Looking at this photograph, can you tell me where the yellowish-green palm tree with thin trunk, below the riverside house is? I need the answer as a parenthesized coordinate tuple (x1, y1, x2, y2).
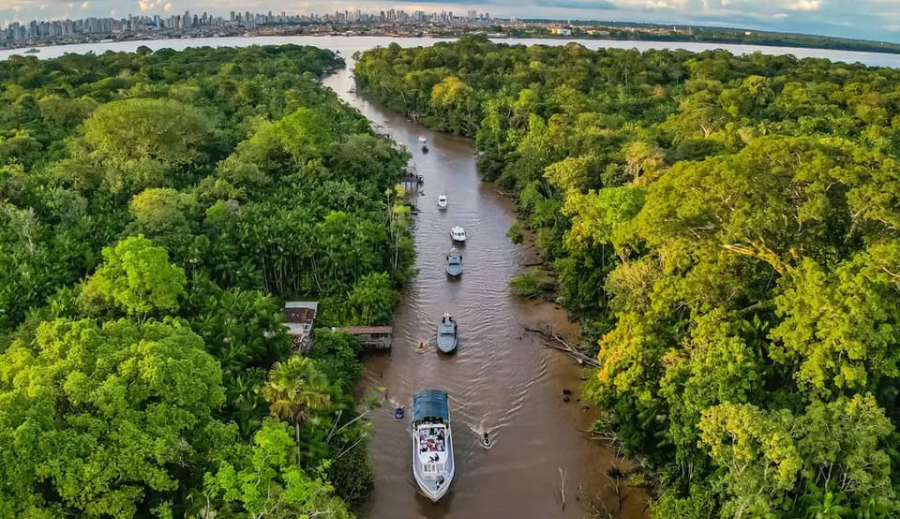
(263, 356, 331, 466)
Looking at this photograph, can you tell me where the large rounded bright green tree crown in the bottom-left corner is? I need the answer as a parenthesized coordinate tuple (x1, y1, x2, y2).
(0, 320, 231, 518)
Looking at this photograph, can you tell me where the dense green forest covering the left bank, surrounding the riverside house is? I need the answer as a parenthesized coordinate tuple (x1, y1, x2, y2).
(0, 46, 413, 519)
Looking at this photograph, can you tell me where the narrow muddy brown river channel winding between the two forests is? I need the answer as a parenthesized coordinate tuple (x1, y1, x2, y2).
(324, 56, 647, 519)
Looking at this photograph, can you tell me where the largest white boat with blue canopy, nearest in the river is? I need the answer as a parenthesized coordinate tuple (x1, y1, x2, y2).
(412, 389, 456, 502)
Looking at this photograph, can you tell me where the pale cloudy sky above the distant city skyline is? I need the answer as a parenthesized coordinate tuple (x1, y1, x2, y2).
(0, 0, 900, 42)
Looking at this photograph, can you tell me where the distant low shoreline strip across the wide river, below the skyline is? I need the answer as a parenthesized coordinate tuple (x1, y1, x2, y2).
(0, 20, 900, 58)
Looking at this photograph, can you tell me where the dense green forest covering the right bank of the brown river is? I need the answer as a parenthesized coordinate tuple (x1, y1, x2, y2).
(355, 37, 900, 519)
